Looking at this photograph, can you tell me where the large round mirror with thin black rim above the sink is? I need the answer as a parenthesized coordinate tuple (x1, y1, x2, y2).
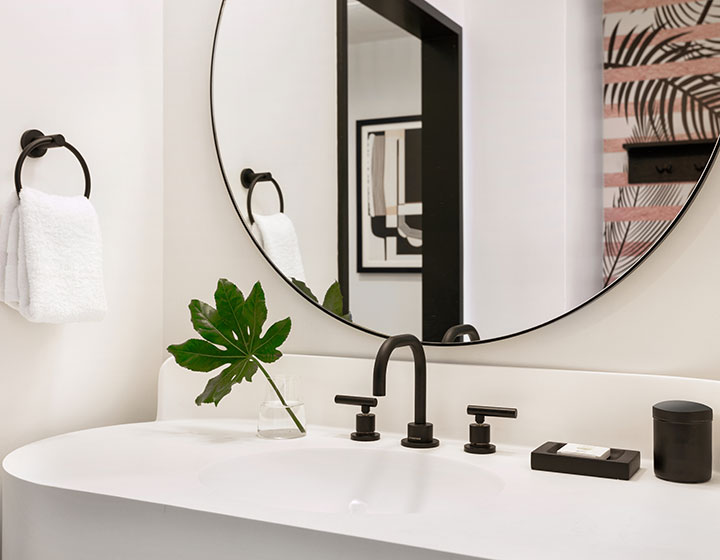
(211, 0, 720, 344)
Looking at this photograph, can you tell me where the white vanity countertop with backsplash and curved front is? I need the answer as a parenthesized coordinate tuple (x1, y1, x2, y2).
(3, 355, 720, 560)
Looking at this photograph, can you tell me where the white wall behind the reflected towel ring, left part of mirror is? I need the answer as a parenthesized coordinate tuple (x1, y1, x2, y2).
(212, 0, 338, 299)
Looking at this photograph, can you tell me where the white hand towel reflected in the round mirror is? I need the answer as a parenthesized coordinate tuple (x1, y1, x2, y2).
(253, 212, 305, 282)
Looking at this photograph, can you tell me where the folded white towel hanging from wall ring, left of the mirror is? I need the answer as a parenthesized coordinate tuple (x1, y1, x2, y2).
(4, 188, 107, 323)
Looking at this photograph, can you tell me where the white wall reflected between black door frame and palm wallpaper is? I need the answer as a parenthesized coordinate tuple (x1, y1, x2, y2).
(464, 0, 602, 338)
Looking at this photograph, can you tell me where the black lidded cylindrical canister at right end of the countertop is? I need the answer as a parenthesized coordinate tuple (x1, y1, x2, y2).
(653, 401, 712, 482)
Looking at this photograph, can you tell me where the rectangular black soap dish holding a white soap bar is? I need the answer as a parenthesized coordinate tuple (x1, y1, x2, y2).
(530, 441, 640, 480)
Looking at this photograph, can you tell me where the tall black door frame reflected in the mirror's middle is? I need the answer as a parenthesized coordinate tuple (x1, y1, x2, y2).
(337, 0, 464, 343)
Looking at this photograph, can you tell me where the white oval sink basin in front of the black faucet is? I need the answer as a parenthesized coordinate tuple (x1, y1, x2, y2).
(199, 448, 503, 515)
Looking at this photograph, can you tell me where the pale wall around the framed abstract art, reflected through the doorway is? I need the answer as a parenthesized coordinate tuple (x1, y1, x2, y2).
(348, 35, 422, 336)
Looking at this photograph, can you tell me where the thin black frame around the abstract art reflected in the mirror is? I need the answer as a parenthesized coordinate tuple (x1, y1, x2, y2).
(355, 115, 422, 274)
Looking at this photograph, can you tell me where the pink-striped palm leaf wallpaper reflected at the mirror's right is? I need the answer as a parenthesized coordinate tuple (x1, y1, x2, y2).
(603, 0, 720, 286)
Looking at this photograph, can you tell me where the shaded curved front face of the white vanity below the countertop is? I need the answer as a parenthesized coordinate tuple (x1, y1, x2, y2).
(2, 468, 478, 560)
